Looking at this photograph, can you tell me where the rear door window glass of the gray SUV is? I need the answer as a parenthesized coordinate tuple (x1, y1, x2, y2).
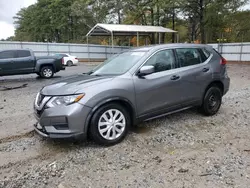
(176, 48, 202, 67)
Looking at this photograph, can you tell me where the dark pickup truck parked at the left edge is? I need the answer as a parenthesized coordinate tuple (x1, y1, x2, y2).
(0, 49, 65, 78)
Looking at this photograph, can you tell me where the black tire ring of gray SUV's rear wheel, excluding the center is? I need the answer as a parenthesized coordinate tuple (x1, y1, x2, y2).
(202, 86, 222, 116)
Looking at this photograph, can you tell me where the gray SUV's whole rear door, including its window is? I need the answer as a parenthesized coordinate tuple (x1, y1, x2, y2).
(176, 48, 212, 106)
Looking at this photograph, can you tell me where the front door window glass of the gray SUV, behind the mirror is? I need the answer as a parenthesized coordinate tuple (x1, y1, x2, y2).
(144, 50, 175, 72)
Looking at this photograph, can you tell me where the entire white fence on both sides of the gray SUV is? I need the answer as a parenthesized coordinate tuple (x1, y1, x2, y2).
(0, 41, 250, 61)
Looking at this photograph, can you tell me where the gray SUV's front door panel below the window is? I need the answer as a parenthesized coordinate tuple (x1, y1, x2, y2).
(134, 69, 182, 116)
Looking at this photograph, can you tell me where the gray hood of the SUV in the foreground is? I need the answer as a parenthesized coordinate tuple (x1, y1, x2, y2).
(41, 75, 113, 96)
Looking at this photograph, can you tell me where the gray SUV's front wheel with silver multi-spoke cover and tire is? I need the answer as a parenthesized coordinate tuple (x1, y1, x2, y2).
(90, 103, 130, 146)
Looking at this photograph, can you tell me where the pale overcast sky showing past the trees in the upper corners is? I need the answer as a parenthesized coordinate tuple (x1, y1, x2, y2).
(0, 0, 250, 39)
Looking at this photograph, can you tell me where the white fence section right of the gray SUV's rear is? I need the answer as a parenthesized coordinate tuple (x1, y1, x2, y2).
(210, 43, 250, 61)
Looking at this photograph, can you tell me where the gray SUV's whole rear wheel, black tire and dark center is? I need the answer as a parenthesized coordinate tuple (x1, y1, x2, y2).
(201, 86, 222, 116)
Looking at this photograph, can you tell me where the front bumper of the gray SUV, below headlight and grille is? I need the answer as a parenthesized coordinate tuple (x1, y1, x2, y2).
(34, 103, 91, 139)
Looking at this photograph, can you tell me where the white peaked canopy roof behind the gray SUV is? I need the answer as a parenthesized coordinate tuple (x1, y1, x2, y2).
(87, 24, 176, 36)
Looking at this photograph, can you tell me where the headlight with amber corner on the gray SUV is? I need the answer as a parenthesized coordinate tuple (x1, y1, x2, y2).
(46, 94, 85, 108)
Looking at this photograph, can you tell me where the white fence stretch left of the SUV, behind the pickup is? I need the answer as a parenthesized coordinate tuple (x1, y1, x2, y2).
(0, 41, 129, 59)
